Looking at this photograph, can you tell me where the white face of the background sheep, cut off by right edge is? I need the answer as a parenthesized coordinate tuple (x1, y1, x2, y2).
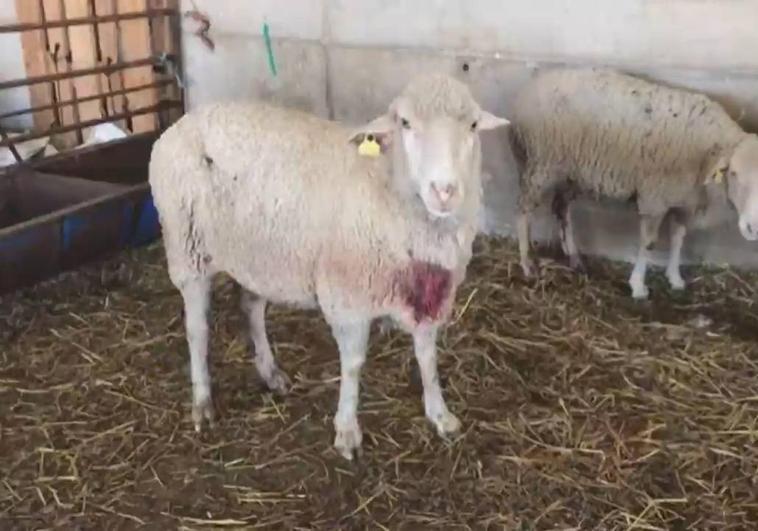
(726, 135, 758, 241)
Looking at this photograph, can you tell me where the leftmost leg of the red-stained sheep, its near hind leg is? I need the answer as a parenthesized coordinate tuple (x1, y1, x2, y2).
(179, 278, 218, 432)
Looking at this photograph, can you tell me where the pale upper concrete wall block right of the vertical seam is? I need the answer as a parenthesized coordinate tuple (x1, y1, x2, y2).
(325, 0, 758, 70)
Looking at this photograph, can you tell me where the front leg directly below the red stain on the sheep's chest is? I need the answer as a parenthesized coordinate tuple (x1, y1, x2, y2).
(413, 325, 461, 436)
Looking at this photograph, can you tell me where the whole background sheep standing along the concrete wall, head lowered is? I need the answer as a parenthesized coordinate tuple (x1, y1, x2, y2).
(509, 69, 758, 298)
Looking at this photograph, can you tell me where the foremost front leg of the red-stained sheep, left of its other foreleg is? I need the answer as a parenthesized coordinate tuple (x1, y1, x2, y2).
(332, 321, 371, 460)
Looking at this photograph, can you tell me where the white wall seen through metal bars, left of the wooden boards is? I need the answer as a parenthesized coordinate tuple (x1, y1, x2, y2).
(0, 0, 32, 129)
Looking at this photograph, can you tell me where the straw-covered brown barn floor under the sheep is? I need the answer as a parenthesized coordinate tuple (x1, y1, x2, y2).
(0, 240, 758, 530)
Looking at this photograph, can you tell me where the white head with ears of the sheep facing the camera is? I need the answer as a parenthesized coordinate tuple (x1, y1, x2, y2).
(351, 75, 509, 218)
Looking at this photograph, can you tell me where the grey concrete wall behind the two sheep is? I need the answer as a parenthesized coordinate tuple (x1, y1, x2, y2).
(183, 0, 758, 265)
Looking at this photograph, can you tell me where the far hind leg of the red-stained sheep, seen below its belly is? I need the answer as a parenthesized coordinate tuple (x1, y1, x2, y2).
(240, 288, 290, 395)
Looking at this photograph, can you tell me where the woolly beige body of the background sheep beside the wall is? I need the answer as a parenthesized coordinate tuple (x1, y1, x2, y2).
(513, 69, 739, 202)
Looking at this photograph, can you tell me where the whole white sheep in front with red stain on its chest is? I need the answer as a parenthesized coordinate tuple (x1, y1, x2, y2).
(150, 72, 508, 459)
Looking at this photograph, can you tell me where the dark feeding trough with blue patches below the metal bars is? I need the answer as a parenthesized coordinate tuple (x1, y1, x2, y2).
(0, 134, 159, 293)
